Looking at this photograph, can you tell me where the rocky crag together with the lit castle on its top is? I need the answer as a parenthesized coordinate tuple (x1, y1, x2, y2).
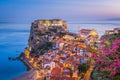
(28, 19, 69, 53)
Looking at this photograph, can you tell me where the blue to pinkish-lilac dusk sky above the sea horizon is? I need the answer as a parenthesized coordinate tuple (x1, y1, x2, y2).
(0, 0, 120, 21)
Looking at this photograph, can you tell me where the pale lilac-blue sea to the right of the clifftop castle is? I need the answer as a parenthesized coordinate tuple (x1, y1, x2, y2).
(68, 21, 120, 36)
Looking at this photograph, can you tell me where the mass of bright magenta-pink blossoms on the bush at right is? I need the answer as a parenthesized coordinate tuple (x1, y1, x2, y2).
(93, 38, 120, 78)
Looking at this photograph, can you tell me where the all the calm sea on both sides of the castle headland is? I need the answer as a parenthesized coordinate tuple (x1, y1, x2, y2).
(0, 21, 120, 80)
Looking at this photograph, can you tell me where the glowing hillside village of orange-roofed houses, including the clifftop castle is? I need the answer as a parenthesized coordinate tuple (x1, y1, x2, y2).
(13, 19, 120, 80)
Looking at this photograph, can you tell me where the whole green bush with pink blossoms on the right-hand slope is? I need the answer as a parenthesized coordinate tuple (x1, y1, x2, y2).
(92, 35, 120, 80)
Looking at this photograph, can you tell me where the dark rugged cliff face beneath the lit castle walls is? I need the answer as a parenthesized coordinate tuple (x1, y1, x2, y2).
(28, 20, 68, 54)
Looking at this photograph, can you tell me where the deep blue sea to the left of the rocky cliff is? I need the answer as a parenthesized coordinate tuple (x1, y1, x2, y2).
(0, 24, 30, 80)
